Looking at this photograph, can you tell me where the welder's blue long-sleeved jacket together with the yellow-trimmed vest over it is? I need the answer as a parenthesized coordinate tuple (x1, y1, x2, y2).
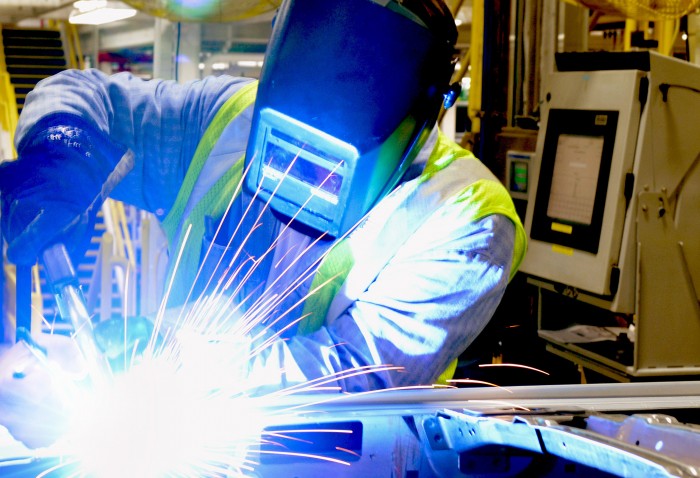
(16, 70, 525, 391)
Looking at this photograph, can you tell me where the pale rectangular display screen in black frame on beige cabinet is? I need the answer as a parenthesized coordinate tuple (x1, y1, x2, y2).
(547, 134, 605, 226)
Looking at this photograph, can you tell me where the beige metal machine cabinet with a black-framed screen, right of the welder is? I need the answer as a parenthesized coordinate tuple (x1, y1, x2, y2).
(521, 52, 700, 381)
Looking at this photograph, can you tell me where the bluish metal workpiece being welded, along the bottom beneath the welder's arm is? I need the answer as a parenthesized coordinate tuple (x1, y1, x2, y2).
(0, 382, 700, 478)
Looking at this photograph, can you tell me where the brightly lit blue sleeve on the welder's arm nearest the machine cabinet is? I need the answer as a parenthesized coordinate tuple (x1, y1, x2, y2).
(251, 213, 514, 392)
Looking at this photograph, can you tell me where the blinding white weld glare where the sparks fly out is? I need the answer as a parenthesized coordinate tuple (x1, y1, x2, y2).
(67, 359, 264, 478)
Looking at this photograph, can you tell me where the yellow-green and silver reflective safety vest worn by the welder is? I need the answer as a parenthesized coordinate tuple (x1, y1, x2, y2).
(163, 82, 526, 380)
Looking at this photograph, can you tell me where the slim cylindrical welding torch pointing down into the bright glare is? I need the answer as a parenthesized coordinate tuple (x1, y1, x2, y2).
(42, 244, 110, 384)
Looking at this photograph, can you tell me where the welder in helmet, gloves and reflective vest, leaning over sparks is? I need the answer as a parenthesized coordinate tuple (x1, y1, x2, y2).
(0, 0, 525, 448)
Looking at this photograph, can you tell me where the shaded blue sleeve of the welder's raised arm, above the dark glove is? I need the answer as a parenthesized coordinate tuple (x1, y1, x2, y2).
(15, 70, 250, 217)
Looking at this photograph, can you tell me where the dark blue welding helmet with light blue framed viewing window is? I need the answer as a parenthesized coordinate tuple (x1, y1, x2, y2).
(245, 0, 457, 237)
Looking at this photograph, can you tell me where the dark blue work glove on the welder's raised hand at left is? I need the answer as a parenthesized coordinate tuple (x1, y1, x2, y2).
(0, 115, 133, 265)
